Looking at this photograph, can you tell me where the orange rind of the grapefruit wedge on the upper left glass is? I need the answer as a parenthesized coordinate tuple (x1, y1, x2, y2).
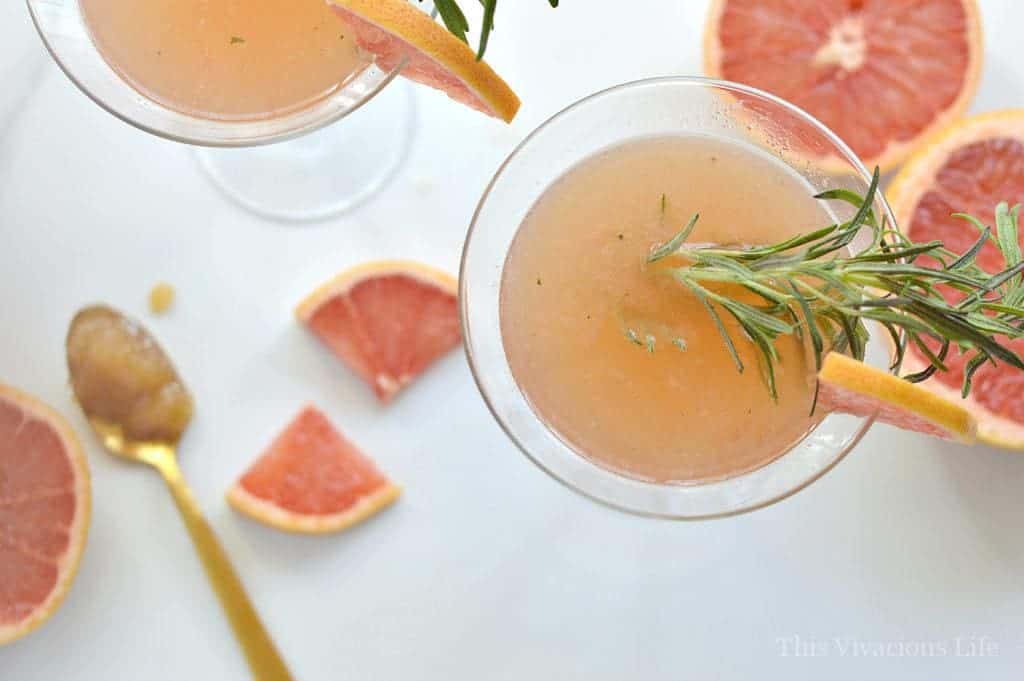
(328, 0, 520, 123)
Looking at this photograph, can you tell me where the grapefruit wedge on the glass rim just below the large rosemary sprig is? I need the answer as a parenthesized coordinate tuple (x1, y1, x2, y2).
(817, 352, 977, 442)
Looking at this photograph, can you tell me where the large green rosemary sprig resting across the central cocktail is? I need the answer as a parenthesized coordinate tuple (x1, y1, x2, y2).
(648, 170, 1024, 398)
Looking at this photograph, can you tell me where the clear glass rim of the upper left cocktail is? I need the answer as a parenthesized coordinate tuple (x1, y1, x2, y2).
(26, 0, 437, 148)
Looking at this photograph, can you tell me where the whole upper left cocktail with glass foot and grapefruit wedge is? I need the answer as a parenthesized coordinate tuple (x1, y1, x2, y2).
(27, 0, 519, 220)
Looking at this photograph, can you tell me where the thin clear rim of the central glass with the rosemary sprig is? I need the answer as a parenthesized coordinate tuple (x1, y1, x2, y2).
(459, 76, 895, 521)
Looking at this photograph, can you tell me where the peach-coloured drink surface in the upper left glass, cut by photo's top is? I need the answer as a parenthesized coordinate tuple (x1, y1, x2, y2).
(81, 0, 365, 120)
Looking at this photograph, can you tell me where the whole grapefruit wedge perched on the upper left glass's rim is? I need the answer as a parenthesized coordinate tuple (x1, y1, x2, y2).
(328, 0, 519, 122)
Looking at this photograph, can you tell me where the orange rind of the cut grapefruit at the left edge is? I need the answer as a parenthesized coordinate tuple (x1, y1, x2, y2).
(0, 383, 92, 645)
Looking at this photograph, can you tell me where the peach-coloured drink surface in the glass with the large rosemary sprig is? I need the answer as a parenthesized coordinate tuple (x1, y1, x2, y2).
(501, 136, 829, 482)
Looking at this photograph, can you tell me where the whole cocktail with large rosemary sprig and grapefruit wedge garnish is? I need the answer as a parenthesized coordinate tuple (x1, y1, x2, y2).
(461, 78, 1024, 518)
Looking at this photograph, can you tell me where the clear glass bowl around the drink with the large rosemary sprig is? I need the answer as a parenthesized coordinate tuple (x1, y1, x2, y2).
(460, 78, 892, 519)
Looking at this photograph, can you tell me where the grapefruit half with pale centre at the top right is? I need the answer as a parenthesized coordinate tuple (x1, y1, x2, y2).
(705, 0, 983, 170)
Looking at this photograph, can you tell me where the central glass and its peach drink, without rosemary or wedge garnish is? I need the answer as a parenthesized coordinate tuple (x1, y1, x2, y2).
(461, 78, 901, 518)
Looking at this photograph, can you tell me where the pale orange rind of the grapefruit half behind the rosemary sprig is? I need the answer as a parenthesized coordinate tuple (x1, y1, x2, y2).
(886, 109, 1024, 451)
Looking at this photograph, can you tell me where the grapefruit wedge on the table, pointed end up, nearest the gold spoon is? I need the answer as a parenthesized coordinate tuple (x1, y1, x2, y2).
(227, 407, 400, 535)
